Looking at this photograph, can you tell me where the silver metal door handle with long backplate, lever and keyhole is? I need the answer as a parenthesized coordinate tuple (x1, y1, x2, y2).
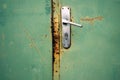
(61, 6, 83, 49)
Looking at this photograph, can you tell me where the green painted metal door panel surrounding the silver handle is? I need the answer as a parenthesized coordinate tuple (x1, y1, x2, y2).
(60, 0, 120, 80)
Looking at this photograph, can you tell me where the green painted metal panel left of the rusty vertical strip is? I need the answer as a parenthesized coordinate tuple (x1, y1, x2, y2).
(0, 0, 52, 80)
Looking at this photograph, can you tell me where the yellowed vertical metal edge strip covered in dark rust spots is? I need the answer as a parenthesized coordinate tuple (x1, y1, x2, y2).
(51, 0, 60, 80)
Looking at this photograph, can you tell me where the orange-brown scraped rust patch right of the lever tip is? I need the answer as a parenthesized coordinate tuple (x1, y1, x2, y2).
(80, 16, 103, 24)
